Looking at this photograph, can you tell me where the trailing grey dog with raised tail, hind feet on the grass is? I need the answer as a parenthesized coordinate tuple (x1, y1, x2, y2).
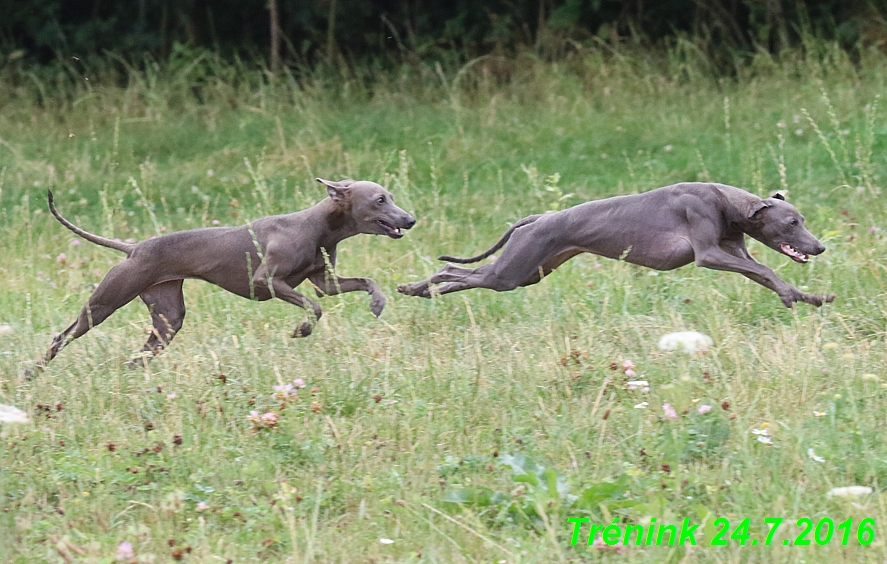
(37, 178, 416, 368)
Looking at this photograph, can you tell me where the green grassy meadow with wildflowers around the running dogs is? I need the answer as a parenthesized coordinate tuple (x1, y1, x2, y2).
(0, 47, 887, 563)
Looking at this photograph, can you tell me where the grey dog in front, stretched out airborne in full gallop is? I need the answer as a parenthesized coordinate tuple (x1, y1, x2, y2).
(397, 182, 835, 307)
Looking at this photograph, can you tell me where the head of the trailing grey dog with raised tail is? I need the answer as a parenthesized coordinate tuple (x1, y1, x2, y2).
(317, 178, 416, 239)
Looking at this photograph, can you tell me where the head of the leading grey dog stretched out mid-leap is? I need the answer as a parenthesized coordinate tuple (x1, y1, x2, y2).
(748, 194, 825, 263)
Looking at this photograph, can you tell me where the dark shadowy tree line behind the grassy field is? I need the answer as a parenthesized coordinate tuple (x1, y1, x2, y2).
(0, 0, 887, 68)
